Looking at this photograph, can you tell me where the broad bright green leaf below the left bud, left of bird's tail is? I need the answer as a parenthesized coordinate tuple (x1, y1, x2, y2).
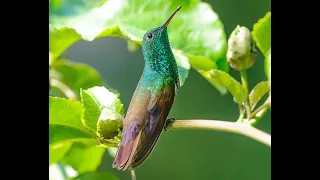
(61, 143, 105, 174)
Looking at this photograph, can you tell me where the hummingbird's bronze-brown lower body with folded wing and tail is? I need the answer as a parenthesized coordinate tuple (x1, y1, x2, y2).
(113, 82, 176, 170)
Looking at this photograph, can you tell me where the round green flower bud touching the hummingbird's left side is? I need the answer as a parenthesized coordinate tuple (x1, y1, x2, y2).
(97, 108, 124, 147)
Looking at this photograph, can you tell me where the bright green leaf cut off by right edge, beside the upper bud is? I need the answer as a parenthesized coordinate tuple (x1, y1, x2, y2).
(252, 12, 271, 56)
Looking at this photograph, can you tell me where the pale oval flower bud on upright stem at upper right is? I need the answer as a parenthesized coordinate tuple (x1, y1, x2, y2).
(227, 25, 257, 71)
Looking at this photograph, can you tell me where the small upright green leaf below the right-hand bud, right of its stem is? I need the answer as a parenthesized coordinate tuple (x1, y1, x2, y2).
(249, 81, 270, 110)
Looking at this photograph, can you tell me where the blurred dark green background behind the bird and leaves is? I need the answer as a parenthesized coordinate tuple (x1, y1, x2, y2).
(64, 0, 271, 180)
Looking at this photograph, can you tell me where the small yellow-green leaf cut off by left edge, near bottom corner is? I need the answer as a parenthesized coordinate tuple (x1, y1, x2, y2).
(49, 143, 72, 165)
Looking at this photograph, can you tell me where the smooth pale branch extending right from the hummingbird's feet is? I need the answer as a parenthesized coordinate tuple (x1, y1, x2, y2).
(166, 119, 271, 147)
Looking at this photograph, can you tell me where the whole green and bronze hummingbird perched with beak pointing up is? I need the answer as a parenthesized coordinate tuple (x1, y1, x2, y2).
(112, 6, 181, 171)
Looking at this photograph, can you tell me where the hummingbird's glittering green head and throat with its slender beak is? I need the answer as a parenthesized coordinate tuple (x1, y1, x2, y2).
(142, 6, 181, 74)
